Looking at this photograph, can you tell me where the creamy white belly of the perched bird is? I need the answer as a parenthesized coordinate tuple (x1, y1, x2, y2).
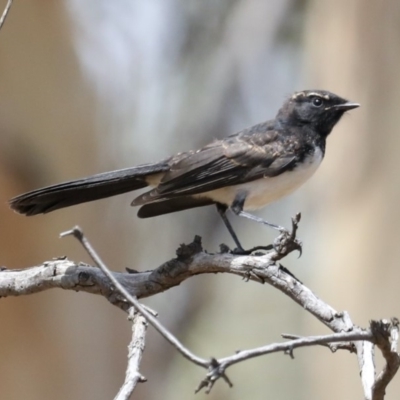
(201, 148, 323, 210)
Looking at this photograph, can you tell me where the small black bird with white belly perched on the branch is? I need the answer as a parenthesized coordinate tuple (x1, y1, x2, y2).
(9, 90, 360, 251)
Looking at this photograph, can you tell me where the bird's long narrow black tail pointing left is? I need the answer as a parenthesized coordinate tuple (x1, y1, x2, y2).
(9, 160, 169, 215)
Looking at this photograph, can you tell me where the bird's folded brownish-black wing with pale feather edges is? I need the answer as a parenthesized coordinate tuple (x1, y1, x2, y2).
(132, 130, 296, 205)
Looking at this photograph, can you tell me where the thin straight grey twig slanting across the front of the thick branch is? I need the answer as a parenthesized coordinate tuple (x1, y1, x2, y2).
(60, 227, 210, 368)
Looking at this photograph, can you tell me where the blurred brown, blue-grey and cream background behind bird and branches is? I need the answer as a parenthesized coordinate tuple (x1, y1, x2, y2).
(0, 0, 400, 400)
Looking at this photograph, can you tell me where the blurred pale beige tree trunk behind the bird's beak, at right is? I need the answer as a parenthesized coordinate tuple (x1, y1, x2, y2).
(304, 0, 400, 399)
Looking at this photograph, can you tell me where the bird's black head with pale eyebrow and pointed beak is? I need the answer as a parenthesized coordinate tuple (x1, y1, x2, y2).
(277, 90, 360, 136)
